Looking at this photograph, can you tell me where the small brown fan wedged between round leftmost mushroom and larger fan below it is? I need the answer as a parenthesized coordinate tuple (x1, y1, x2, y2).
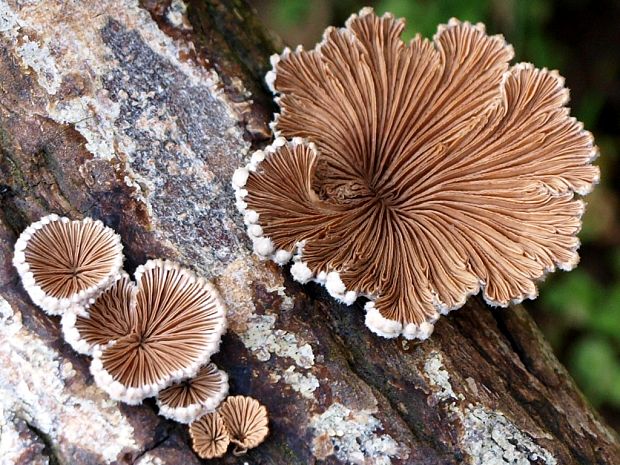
(61, 272, 137, 355)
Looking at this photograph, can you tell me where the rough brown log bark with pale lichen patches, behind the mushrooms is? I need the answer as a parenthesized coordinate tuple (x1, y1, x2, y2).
(0, 0, 620, 465)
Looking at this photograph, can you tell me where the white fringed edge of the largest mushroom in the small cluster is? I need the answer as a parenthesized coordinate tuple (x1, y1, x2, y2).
(90, 259, 226, 405)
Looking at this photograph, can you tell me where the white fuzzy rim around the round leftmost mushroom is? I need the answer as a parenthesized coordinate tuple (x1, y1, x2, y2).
(13, 213, 124, 315)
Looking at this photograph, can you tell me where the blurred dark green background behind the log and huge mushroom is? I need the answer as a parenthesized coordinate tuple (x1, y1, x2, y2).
(251, 0, 620, 430)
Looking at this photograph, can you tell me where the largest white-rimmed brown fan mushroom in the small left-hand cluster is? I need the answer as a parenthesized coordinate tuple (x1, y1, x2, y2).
(91, 260, 226, 404)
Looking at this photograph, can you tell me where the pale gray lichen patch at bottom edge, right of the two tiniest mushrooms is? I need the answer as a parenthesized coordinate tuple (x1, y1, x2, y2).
(310, 403, 400, 465)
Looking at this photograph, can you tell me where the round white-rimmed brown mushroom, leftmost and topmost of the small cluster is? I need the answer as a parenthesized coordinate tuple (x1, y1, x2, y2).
(13, 214, 123, 315)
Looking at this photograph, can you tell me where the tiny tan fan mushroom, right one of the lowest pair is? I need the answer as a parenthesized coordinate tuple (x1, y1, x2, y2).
(218, 396, 269, 454)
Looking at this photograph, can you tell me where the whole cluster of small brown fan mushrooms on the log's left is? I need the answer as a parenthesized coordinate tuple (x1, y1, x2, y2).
(13, 214, 269, 458)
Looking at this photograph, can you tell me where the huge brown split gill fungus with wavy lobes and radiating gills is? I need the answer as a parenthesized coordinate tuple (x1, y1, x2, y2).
(232, 8, 599, 339)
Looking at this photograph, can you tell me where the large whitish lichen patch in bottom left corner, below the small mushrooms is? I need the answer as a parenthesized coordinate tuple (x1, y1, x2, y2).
(0, 297, 137, 463)
